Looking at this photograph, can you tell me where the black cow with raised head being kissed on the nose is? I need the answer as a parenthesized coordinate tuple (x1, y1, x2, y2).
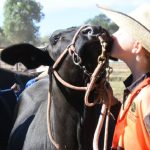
(1, 26, 120, 150)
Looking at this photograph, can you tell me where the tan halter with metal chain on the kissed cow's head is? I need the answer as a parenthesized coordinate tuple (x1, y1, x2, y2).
(47, 25, 111, 149)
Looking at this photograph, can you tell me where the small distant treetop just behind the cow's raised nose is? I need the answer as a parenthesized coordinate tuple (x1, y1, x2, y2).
(85, 14, 118, 33)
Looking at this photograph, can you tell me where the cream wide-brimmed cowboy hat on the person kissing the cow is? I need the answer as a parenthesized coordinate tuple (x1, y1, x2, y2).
(98, 4, 150, 52)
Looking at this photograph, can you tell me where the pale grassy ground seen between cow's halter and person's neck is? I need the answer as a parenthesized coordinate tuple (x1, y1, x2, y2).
(110, 62, 130, 101)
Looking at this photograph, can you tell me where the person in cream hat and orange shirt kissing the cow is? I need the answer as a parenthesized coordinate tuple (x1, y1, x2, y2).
(99, 4, 150, 150)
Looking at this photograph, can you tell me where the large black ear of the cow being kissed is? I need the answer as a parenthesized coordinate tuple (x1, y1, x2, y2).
(1, 43, 54, 69)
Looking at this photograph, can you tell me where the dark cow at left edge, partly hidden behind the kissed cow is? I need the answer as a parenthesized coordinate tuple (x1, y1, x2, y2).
(0, 68, 38, 150)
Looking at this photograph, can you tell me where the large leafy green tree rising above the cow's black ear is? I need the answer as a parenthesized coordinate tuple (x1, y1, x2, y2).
(3, 0, 44, 43)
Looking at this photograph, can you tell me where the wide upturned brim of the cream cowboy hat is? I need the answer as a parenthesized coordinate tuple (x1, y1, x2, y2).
(97, 5, 150, 52)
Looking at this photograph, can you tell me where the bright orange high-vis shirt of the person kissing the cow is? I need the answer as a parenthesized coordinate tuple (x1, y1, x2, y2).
(112, 77, 150, 150)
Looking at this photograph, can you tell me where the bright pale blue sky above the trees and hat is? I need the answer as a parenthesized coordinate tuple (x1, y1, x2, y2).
(0, 0, 150, 36)
